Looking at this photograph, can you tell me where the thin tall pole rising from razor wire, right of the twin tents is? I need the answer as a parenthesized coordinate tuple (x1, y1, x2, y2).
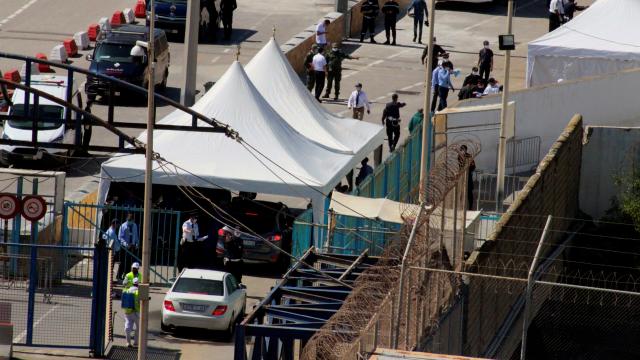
(414, 0, 437, 202)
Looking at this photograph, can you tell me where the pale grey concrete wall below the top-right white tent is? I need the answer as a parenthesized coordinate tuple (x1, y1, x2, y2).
(448, 69, 640, 171)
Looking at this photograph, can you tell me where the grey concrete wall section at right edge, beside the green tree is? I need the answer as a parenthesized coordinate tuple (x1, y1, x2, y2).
(580, 126, 640, 219)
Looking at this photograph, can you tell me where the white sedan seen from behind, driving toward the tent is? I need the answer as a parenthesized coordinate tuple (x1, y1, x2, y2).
(161, 269, 247, 338)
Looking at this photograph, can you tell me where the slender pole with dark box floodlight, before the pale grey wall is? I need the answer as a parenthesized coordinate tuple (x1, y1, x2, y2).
(496, 0, 514, 212)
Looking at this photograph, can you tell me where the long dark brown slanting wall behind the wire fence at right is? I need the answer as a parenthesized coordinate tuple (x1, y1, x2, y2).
(465, 116, 583, 355)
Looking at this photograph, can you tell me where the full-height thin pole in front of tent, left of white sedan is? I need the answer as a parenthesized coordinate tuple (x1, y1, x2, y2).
(137, 0, 156, 360)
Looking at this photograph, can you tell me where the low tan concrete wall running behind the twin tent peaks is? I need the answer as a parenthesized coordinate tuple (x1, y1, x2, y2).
(281, 0, 411, 74)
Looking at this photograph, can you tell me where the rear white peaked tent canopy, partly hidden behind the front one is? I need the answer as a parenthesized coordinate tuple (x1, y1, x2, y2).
(246, 39, 384, 158)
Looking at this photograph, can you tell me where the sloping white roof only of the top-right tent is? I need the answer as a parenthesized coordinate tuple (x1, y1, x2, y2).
(528, 0, 640, 61)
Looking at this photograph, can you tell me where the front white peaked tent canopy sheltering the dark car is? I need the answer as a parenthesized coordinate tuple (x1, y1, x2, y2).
(100, 62, 353, 226)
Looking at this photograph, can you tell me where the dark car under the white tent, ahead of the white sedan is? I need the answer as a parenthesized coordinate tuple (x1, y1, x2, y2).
(216, 197, 295, 267)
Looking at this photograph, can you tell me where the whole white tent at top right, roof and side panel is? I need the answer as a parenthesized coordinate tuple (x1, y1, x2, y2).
(527, 0, 640, 87)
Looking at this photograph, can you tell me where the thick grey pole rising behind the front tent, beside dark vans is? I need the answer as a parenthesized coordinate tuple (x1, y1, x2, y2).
(180, 0, 200, 107)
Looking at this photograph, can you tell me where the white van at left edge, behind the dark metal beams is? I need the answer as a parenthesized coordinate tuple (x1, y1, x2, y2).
(0, 75, 82, 165)
